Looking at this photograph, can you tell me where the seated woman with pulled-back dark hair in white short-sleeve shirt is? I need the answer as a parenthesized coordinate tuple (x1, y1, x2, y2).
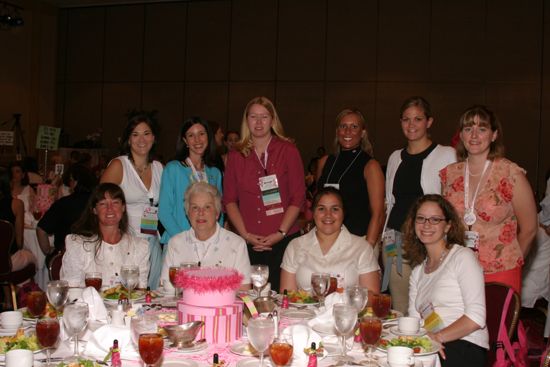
(280, 187, 380, 293)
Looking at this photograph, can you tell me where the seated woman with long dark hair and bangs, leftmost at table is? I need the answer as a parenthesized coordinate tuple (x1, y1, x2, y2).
(60, 183, 149, 288)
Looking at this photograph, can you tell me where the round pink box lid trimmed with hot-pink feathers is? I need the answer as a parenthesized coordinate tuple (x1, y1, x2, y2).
(176, 267, 244, 293)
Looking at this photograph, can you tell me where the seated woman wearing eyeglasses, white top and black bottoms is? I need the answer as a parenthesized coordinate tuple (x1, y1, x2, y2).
(403, 194, 489, 367)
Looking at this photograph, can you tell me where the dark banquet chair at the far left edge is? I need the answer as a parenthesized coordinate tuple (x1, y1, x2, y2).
(0, 219, 36, 310)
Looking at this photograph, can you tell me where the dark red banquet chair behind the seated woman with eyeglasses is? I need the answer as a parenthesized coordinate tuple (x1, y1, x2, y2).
(485, 282, 521, 366)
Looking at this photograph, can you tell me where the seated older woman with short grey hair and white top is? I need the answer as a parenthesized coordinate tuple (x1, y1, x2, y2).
(161, 182, 250, 292)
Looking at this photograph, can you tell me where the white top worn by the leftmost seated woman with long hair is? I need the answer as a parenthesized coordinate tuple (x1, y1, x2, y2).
(60, 234, 149, 288)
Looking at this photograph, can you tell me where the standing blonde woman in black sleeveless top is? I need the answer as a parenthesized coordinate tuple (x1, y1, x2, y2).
(317, 108, 384, 248)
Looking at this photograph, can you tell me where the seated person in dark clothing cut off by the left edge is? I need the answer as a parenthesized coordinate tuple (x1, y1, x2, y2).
(0, 180, 36, 271)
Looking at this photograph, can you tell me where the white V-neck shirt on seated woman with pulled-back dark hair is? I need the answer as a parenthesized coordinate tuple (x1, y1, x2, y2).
(281, 226, 380, 289)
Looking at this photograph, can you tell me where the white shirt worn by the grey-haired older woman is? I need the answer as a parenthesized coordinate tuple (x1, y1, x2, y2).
(161, 223, 250, 289)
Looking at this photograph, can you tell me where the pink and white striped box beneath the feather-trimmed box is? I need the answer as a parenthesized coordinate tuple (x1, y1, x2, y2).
(178, 301, 243, 344)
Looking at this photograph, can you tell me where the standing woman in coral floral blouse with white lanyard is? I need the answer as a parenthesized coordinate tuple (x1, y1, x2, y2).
(440, 106, 537, 294)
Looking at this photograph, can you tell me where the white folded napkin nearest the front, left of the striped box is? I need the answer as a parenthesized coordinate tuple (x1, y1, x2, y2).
(84, 325, 139, 359)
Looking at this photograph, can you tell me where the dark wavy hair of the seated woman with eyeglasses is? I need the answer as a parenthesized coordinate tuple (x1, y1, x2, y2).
(402, 194, 464, 267)
